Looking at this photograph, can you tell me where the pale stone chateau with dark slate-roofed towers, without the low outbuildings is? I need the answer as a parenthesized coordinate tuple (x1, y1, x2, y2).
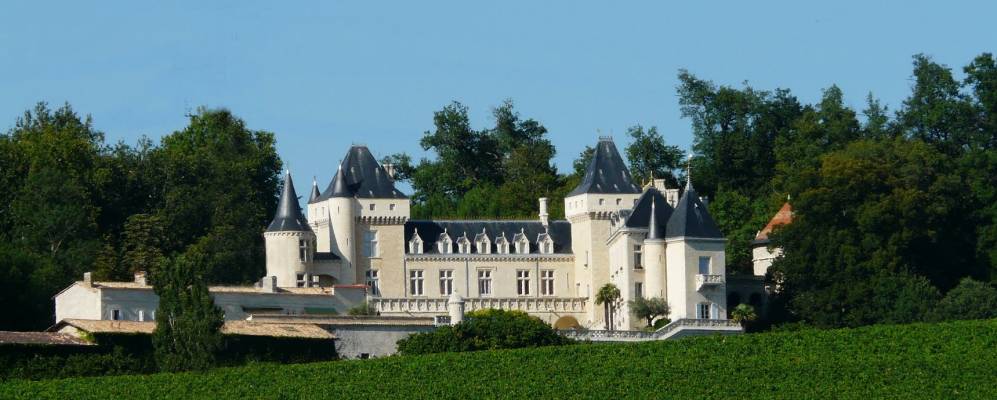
(264, 138, 727, 330)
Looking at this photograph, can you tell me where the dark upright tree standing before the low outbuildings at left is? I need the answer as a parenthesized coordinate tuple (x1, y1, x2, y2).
(152, 251, 224, 371)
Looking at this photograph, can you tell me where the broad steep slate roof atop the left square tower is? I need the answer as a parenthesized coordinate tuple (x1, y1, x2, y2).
(316, 145, 406, 201)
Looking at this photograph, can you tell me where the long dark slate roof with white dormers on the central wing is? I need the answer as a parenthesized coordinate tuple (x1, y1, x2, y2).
(405, 220, 571, 254)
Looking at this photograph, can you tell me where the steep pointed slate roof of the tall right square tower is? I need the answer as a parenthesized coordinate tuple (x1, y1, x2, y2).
(568, 138, 640, 196)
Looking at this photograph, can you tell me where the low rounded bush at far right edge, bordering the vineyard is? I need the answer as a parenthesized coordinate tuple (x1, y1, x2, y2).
(929, 278, 997, 321)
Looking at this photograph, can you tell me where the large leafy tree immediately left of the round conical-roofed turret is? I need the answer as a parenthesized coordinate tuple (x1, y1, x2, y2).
(151, 108, 281, 283)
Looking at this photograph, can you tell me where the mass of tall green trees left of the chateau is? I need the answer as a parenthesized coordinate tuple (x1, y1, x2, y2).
(0, 104, 281, 330)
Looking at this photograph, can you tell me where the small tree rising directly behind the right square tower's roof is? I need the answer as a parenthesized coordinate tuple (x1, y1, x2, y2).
(626, 125, 684, 187)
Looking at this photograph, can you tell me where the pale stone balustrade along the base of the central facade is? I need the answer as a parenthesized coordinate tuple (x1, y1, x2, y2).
(370, 297, 587, 314)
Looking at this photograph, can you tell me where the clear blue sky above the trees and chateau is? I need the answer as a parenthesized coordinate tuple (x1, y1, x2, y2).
(0, 1, 997, 190)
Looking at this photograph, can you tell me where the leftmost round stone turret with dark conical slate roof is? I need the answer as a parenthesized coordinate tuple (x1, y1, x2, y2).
(263, 172, 315, 287)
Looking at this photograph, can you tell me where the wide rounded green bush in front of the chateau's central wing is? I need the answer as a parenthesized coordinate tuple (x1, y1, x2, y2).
(398, 309, 573, 355)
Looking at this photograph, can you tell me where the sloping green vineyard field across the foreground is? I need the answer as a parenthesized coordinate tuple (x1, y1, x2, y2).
(0, 320, 997, 399)
